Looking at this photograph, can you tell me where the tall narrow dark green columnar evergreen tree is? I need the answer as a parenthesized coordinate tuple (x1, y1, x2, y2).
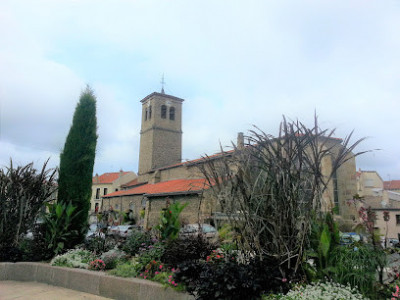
(58, 86, 97, 247)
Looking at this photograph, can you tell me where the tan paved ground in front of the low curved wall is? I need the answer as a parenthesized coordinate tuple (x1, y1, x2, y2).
(0, 281, 110, 300)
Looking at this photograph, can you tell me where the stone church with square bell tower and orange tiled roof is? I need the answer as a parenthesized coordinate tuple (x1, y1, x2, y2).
(101, 90, 356, 229)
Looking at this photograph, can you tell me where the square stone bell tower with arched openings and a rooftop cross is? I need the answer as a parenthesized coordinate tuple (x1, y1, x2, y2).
(138, 89, 184, 175)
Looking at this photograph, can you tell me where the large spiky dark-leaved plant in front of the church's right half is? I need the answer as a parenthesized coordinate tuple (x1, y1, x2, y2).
(200, 117, 364, 278)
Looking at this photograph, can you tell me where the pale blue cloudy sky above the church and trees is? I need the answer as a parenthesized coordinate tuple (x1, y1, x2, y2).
(0, 0, 400, 180)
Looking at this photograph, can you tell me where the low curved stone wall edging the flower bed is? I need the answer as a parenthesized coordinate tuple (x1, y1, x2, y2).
(0, 262, 193, 300)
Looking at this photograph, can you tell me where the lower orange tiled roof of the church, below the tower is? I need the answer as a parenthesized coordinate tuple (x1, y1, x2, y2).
(103, 179, 209, 198)
